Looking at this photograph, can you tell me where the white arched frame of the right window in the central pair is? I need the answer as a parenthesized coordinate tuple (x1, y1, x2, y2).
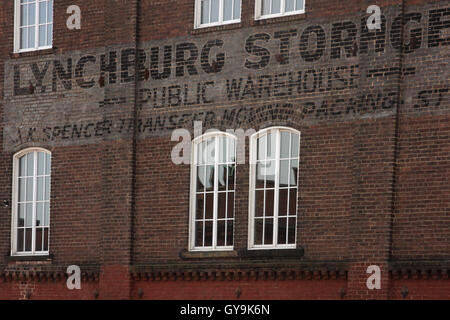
(248, 127, 301, 250)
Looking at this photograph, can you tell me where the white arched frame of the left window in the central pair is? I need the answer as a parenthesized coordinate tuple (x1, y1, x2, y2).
(189, 131, 237, 251)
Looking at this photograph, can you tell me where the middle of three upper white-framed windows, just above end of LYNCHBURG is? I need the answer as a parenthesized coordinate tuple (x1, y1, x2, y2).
(195, 0, 242, 28)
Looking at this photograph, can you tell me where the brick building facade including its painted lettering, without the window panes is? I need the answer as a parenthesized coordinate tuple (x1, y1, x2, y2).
(0, 0, 450, 299)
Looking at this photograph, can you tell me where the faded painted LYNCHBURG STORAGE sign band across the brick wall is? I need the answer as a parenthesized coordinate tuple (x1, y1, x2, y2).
(4, 7, 450, 147)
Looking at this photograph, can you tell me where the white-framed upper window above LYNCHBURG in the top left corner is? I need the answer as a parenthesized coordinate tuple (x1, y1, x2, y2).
(14, 0, 53, 52)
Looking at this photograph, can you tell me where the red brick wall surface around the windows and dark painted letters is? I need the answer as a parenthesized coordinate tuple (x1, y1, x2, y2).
(0, 0, 450, 299)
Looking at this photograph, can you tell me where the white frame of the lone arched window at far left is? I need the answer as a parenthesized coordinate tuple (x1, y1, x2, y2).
(11, 147, 52, 256)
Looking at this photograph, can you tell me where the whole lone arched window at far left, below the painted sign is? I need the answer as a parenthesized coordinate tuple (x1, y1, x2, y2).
(11, 148, 51, 255)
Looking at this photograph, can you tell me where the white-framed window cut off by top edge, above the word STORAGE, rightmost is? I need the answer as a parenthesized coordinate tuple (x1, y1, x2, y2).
(255, 0, 305, 19)
